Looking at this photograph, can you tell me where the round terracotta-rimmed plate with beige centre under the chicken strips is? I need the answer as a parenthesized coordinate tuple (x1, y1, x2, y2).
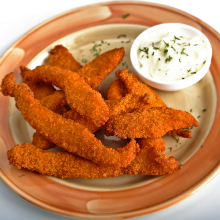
(0, 1, 220, 219)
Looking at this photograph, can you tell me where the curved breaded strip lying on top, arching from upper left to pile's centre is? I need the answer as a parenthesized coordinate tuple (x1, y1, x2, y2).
(23, 65, 109, 127)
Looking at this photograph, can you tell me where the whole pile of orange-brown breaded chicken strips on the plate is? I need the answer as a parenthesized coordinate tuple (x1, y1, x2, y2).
(1, 45, 199, 179)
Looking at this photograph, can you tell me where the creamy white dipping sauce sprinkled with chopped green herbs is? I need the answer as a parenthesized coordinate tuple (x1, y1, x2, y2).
(138, 31, 208, 81)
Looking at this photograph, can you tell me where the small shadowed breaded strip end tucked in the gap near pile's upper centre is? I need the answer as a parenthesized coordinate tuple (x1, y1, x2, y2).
(107, 79, 128, 100)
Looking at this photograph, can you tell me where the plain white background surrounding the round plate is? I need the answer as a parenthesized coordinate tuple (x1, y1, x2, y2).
(0, 0, 220, 220)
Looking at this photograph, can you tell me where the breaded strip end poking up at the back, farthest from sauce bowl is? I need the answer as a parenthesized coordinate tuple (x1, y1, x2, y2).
(49, 45, 82, 72)
